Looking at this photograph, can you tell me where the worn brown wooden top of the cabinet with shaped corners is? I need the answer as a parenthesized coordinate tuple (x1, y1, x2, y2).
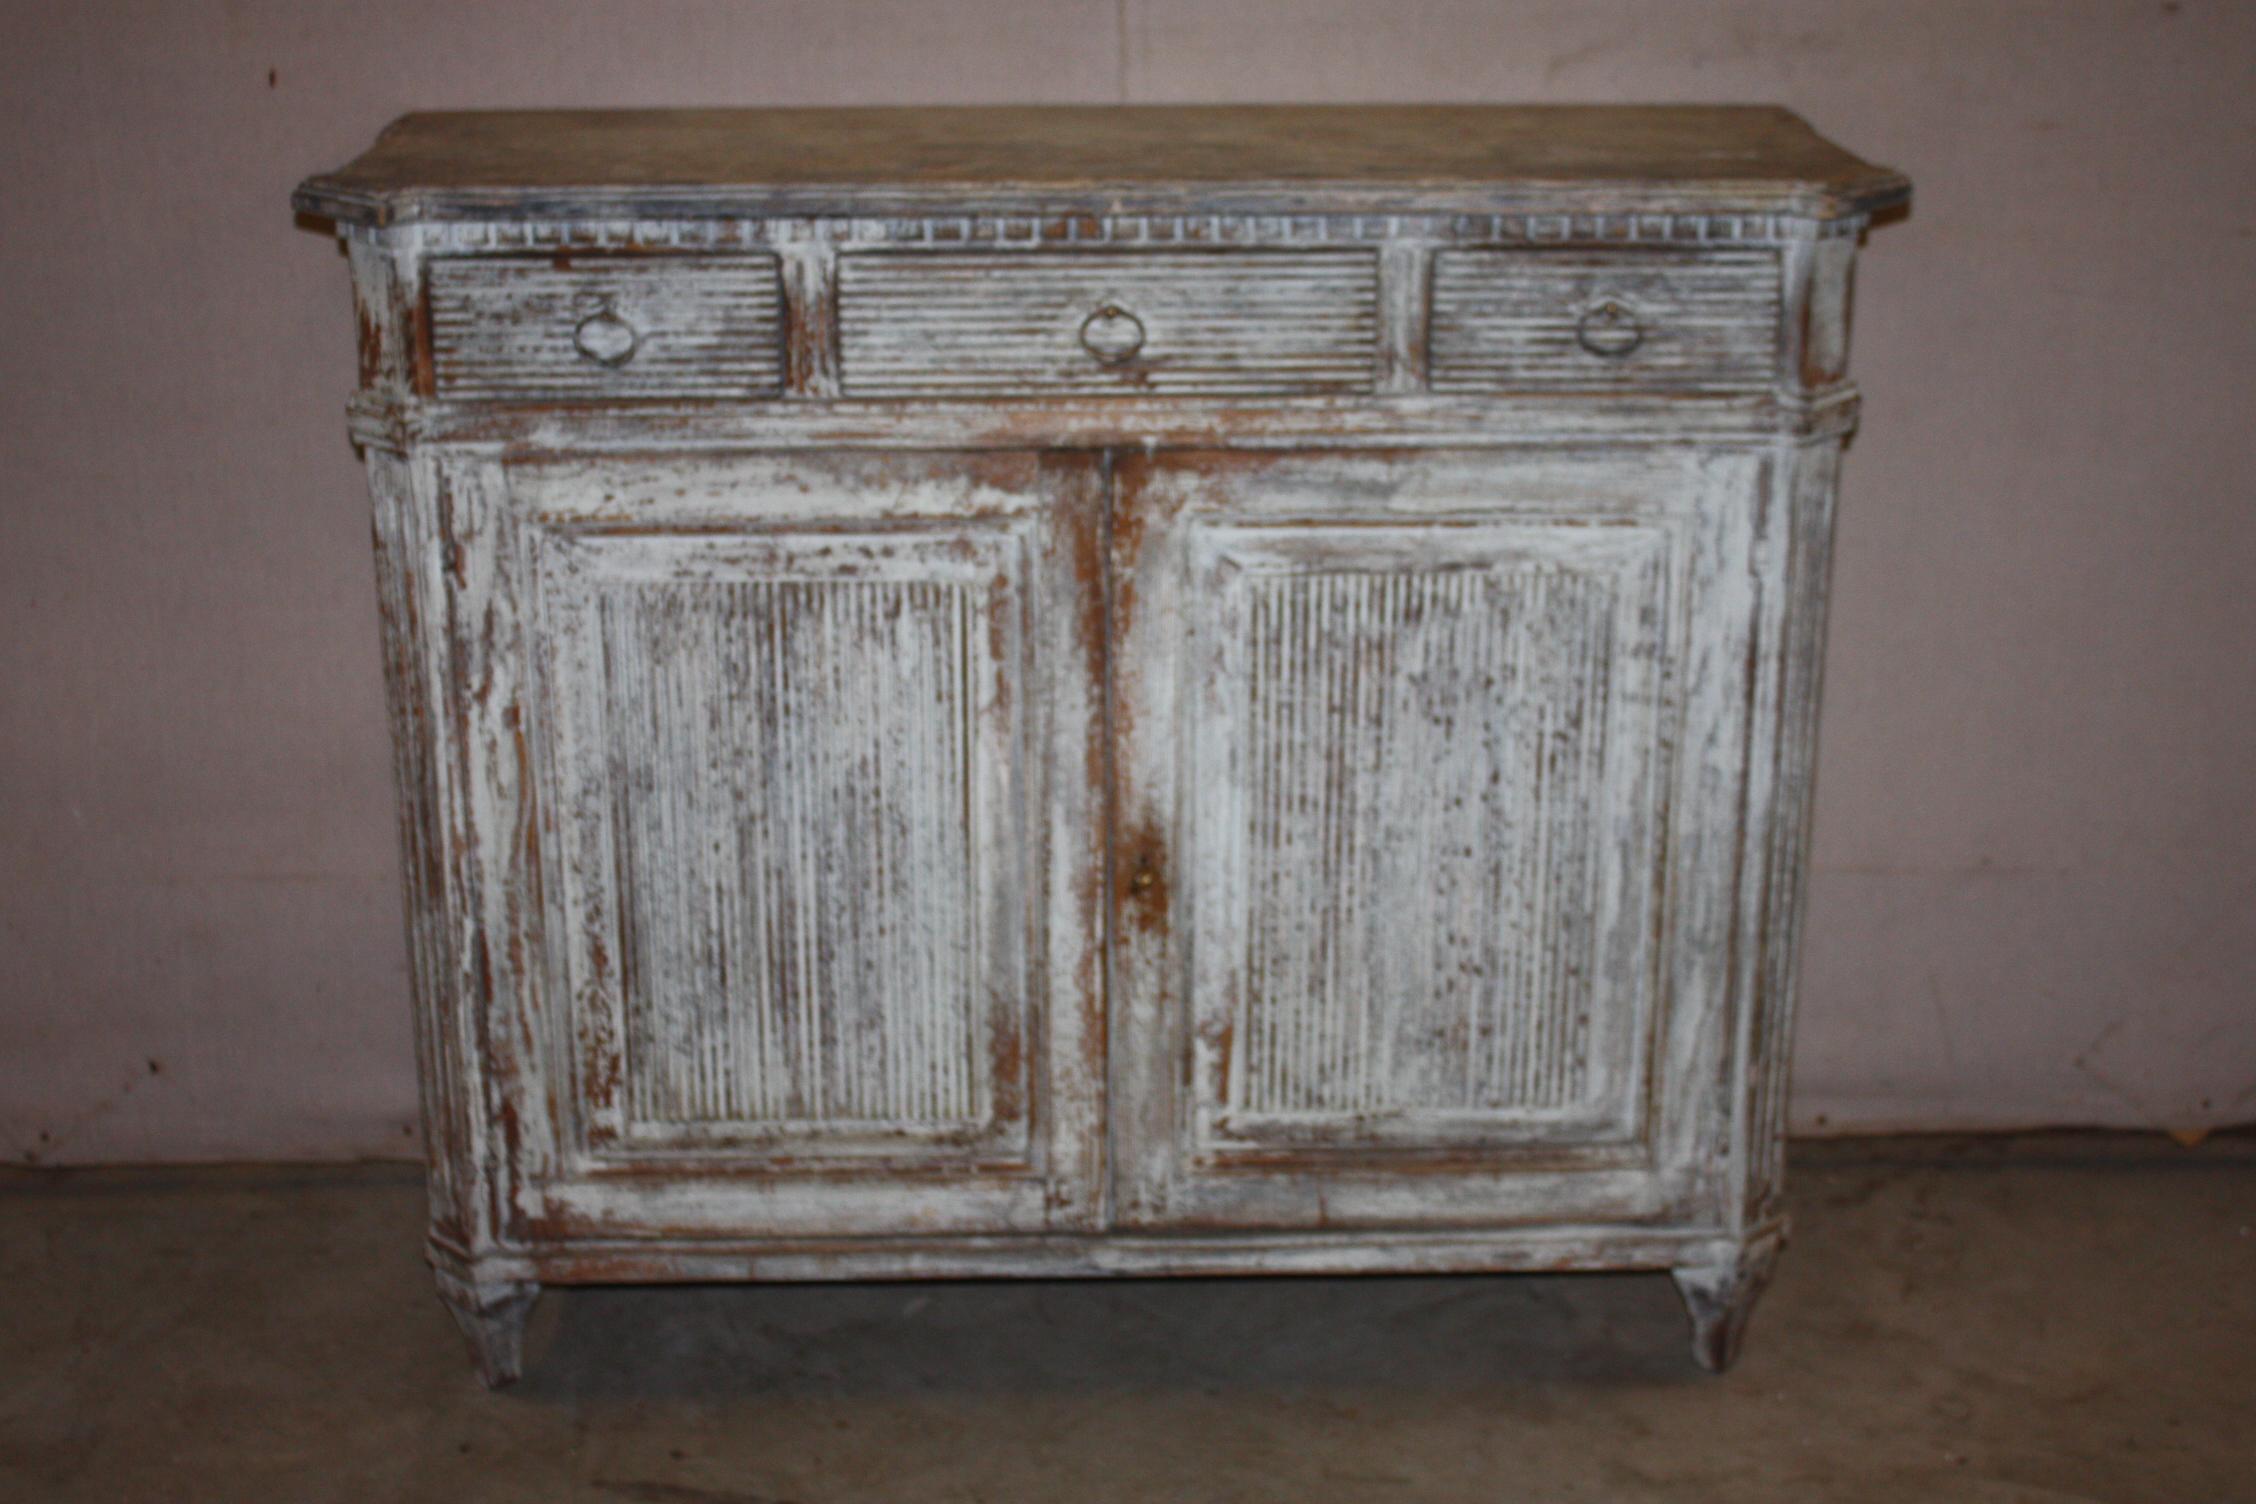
(296, 106, 1911, 225)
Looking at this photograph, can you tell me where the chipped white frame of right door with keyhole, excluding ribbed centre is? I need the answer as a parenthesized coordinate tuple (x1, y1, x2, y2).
(1112, 446, 1775, 1229)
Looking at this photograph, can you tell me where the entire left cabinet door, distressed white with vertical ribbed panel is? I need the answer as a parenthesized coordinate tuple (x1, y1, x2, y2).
(505, 455, 1103, 1240)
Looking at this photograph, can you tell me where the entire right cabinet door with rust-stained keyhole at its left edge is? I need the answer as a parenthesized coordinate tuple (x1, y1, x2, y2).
(1112, 449, 1771, 1229)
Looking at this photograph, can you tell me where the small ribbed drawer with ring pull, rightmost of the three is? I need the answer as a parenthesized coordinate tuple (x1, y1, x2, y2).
(1433, 250, 1780, 392)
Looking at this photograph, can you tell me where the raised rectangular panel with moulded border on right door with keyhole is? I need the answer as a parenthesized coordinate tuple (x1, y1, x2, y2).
(1178, 516, 1681, 1164)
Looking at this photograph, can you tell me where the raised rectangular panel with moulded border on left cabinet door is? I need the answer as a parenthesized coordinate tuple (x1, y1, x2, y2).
(535, 516, 1033, 1173)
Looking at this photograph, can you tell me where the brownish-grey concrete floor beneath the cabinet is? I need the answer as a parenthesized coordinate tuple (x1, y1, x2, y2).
(0, 1136, 2256, 1504)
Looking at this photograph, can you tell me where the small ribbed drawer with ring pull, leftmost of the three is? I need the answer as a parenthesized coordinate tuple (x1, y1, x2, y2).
(429, 255, 783, 401)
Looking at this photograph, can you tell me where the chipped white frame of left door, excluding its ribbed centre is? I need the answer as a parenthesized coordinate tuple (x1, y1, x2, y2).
(442, 451, 1105, 1247)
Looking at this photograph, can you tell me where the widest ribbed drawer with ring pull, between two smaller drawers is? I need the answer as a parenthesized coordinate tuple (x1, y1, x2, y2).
(839, 250, 1378, 397)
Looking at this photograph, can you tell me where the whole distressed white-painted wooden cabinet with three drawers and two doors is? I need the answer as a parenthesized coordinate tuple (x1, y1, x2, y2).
(296, 108, 1909, 1382)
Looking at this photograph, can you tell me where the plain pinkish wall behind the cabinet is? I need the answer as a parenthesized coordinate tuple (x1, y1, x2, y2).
(0, 0, 2256, 1164)
